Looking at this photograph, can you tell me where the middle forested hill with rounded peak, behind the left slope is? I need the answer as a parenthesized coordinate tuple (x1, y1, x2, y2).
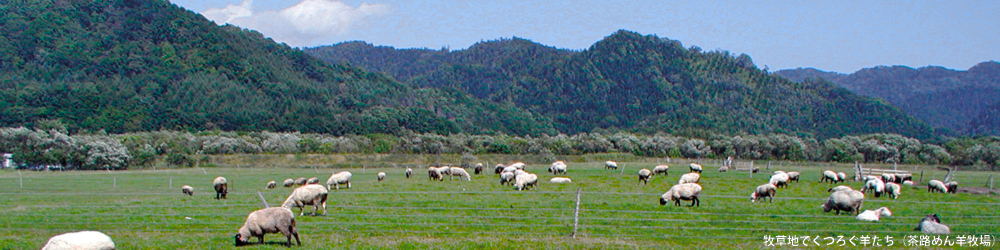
(306, 31, 933, 139)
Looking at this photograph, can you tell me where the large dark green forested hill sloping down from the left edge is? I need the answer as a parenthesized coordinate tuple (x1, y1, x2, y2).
(0, 0, 556, 135)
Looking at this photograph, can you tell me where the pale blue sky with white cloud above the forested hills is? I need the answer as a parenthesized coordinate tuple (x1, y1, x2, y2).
(170, 0, 1000, 73)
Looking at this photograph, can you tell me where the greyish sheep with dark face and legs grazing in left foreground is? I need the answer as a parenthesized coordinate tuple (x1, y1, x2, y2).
(234, 207, 300, 247)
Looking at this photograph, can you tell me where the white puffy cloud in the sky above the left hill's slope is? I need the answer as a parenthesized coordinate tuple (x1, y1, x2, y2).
(202, 0, 391, 46)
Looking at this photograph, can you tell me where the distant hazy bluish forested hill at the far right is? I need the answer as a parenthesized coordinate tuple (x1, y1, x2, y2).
(777, 61, 1000, 135)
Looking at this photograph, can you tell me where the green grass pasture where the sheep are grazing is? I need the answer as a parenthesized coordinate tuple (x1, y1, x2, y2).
(0, 155, 1000, 249)
